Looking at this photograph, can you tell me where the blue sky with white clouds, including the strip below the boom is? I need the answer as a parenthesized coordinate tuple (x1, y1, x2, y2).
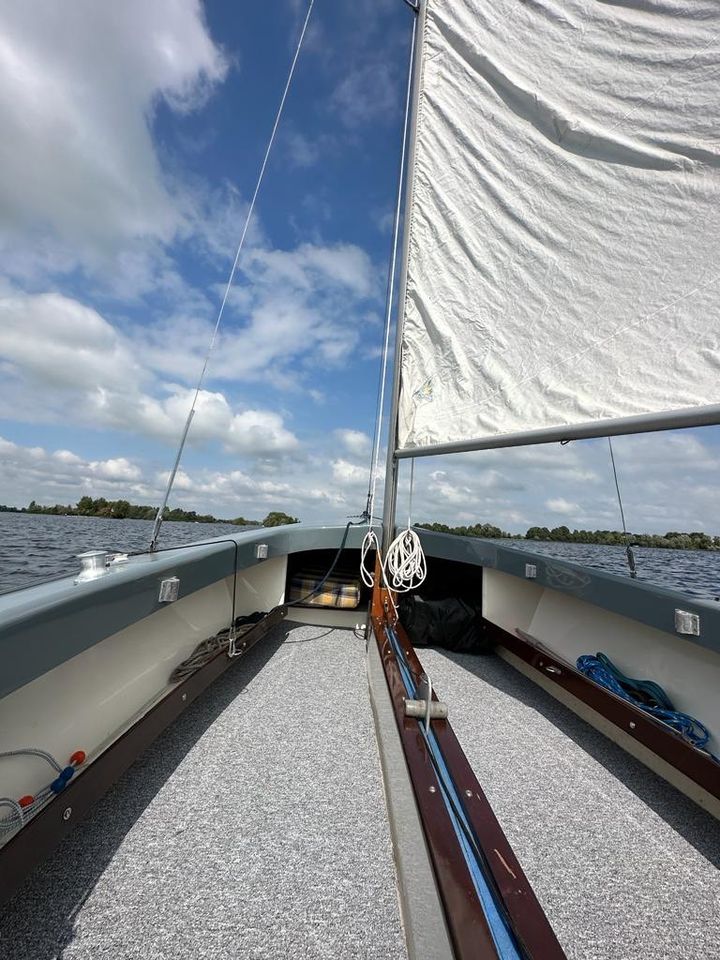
(0, 0, 720, 534)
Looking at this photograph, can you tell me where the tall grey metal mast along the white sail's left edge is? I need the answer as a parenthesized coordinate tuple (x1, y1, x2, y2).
(382, 0, 427, 553)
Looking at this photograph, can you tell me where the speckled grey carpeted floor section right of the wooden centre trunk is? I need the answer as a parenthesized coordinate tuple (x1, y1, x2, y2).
(419, 650, 720, 960)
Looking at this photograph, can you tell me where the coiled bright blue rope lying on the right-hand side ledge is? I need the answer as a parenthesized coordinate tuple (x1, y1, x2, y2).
(577, 653, 717, 760)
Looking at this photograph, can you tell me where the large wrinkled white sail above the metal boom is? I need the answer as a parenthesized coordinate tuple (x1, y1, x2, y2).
(398, 0, 720, 450)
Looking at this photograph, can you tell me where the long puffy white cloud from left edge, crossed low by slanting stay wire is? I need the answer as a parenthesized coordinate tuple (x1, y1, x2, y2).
(0, 294, 298, 455)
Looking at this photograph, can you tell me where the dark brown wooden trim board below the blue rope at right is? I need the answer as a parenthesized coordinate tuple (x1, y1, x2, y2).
(484, 620, 720, 799)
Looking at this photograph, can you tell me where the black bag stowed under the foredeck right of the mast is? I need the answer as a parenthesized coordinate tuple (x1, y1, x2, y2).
(400, 594, 490, 653)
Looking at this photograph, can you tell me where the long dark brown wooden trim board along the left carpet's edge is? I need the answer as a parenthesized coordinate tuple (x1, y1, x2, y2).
(0, 606, 287, 904)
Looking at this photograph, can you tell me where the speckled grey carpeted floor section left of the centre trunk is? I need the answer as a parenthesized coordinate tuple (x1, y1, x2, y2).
(0, 624, 406, 960)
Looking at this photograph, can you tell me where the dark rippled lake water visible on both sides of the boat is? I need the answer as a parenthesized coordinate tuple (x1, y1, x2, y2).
(0, 513, 720, 600)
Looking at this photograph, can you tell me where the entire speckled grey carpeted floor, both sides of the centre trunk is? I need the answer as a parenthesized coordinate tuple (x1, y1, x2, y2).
(0, 622, 720, 960)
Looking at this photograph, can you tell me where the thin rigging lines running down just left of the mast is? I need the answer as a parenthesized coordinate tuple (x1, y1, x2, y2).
(360, 11, 417, 587)
